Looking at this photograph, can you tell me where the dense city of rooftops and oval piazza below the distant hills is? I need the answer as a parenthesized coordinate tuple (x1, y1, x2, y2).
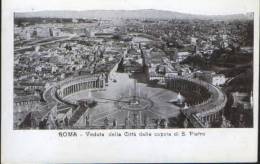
(13, 10, 254, 129)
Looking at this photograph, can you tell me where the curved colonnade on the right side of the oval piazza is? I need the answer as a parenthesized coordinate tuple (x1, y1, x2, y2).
(166, 76, 227, 128)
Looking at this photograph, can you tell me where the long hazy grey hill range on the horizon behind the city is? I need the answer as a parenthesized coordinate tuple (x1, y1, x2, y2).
(15, 9, 253, 20)
